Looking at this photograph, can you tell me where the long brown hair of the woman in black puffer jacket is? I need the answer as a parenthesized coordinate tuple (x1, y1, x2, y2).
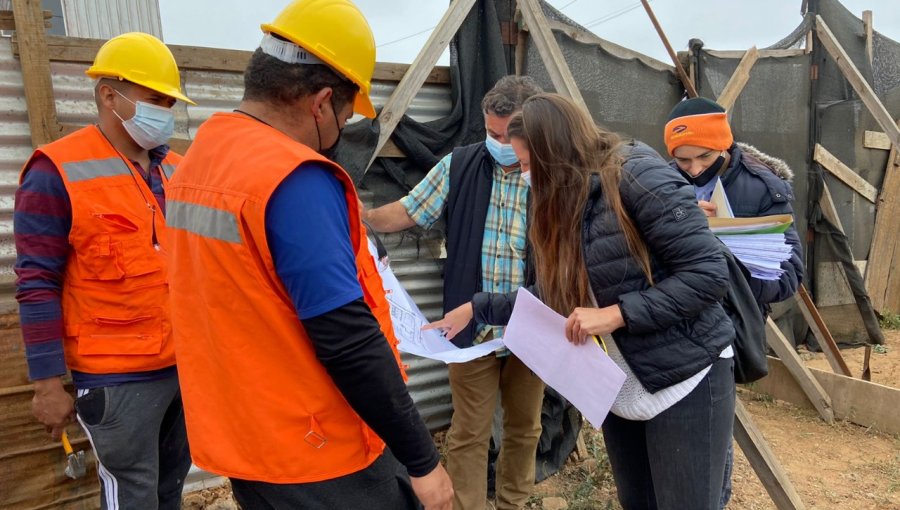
(507, 94, 653, 315)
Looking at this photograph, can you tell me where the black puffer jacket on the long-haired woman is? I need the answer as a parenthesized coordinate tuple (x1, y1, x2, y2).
(473, 142, 734, 392)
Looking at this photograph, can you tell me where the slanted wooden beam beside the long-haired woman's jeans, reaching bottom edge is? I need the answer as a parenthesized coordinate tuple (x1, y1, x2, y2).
(734, 399, 806, 510)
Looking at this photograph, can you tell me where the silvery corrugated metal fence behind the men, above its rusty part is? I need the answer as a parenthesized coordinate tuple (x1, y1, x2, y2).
(0, 35, 451, 429)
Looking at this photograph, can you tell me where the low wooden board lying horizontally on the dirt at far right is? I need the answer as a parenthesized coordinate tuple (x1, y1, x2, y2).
(747, 357, 900, 434)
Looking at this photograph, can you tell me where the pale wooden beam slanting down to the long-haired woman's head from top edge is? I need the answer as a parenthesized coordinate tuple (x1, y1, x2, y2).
(519, 0, 590, 112)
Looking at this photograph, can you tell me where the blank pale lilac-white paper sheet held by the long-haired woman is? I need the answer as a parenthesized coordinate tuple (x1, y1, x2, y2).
(503, 289, 625, 429)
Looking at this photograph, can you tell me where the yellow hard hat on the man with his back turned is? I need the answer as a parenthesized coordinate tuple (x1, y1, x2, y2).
(262, 0, 375, 118)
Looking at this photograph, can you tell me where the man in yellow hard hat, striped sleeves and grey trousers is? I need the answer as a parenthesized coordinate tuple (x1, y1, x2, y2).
(14, 32, 193, 509)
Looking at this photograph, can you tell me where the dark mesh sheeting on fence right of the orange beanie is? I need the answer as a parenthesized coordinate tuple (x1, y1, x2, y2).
(695, 0, 900, 347)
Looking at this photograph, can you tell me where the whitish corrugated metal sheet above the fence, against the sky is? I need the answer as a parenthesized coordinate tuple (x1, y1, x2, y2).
(62, 0, 162, 39)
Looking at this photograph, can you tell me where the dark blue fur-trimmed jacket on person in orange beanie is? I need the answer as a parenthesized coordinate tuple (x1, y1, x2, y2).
(669, 144, 803, 315)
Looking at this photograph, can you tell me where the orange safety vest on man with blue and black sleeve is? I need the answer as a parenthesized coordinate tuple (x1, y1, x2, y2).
(167, 113, 405, 483)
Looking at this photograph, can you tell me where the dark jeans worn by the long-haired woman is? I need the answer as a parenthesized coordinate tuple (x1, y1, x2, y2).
(603, 358, 734, 510)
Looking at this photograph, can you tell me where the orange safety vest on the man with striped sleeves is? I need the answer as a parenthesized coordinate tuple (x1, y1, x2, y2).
(20, 126, 181, 374)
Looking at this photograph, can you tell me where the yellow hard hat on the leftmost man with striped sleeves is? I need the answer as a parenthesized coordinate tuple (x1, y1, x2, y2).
(85, 32, 197, 104)
